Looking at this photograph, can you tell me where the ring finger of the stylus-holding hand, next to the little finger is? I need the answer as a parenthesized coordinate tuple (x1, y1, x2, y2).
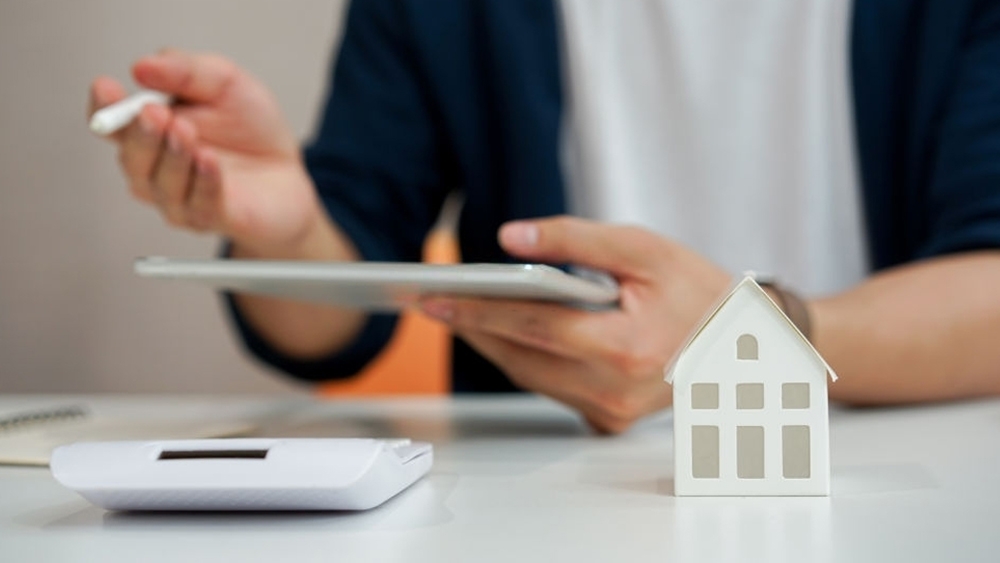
(152, 117, 197, 226)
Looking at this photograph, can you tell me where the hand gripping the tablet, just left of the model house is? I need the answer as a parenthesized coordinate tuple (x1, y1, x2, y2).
(422, 217, 731, 433)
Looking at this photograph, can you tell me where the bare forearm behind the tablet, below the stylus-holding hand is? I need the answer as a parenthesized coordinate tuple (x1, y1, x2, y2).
(231, 212, 366, 360)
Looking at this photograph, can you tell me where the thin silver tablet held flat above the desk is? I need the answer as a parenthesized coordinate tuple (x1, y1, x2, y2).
(135, 257, 618, 311)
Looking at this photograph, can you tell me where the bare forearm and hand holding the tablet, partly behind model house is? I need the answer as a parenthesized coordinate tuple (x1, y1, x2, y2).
(424, 217, 1000, 433)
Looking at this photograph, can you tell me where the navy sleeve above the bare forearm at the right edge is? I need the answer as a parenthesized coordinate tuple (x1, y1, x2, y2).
(917, 2, 1000, 258)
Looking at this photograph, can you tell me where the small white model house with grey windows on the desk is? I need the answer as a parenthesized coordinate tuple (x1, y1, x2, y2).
(666, 277, 837, 496)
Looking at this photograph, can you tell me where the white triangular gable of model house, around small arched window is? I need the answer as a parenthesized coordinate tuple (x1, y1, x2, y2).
(666, 277, 836, 384)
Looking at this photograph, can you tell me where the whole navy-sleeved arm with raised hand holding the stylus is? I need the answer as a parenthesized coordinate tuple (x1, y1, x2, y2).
(91, 0, 455, 379)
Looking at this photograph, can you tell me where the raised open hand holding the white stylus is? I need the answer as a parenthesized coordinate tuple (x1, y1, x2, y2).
(90, 50, 325, 256)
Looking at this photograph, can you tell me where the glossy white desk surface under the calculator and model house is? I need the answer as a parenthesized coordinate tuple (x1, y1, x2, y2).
(0, 396, 1000, 563)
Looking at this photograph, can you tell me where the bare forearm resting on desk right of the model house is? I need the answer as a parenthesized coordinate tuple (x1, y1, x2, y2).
(809, 251, 1000, 404)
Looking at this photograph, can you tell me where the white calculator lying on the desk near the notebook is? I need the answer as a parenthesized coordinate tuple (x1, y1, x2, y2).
(50, 438, 434, 511)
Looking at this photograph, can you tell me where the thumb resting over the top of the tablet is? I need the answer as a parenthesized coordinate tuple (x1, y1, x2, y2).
(498, 216, 669, 274)
